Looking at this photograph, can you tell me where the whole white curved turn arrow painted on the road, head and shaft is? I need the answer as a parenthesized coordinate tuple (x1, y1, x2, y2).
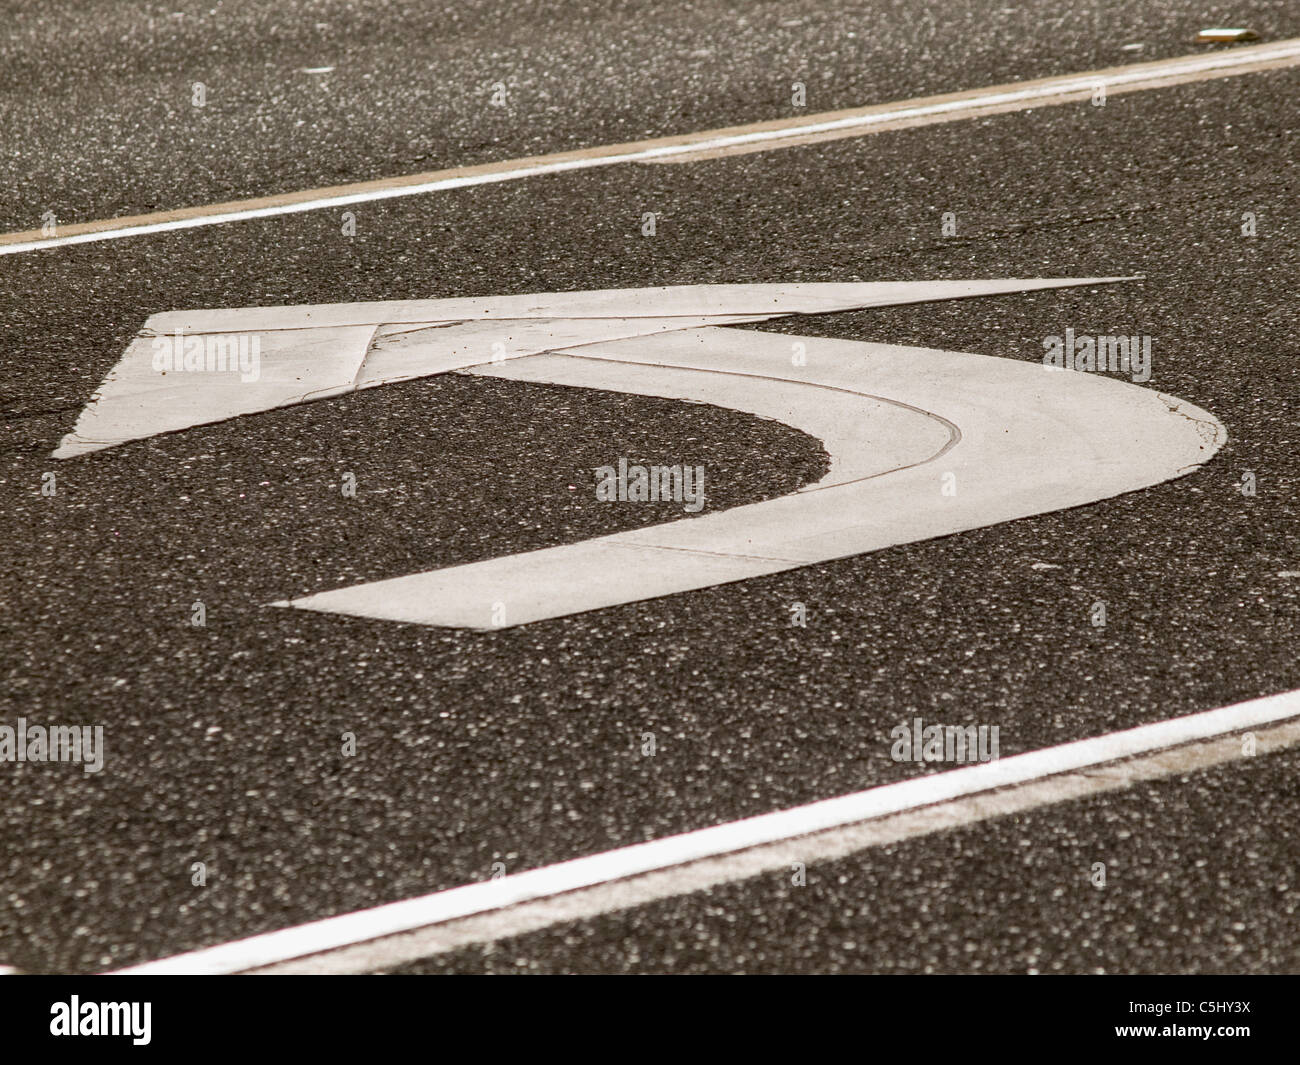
(55, 278, 1227, 628)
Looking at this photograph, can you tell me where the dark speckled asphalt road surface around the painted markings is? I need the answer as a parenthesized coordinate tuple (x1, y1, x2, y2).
(0, 0, 1300, 973)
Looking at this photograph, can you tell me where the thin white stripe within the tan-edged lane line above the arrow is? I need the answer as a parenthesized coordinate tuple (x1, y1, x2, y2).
(0, 40, 1300, 255)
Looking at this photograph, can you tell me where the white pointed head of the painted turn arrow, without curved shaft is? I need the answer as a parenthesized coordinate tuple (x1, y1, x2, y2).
(53, 277, 1102, 459)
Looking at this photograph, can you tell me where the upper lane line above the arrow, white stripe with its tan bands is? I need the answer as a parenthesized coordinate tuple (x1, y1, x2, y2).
(0, 38, 1300, 255)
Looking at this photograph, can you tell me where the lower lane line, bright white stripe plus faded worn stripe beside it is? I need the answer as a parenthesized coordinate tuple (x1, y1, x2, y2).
(116, 692, 1300, 975)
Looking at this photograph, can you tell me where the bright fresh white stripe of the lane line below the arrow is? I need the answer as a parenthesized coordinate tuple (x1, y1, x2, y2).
(116, 690, 1300, 975)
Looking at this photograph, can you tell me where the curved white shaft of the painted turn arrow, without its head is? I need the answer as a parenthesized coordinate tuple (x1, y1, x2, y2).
(276, 321, 1227, 629)
